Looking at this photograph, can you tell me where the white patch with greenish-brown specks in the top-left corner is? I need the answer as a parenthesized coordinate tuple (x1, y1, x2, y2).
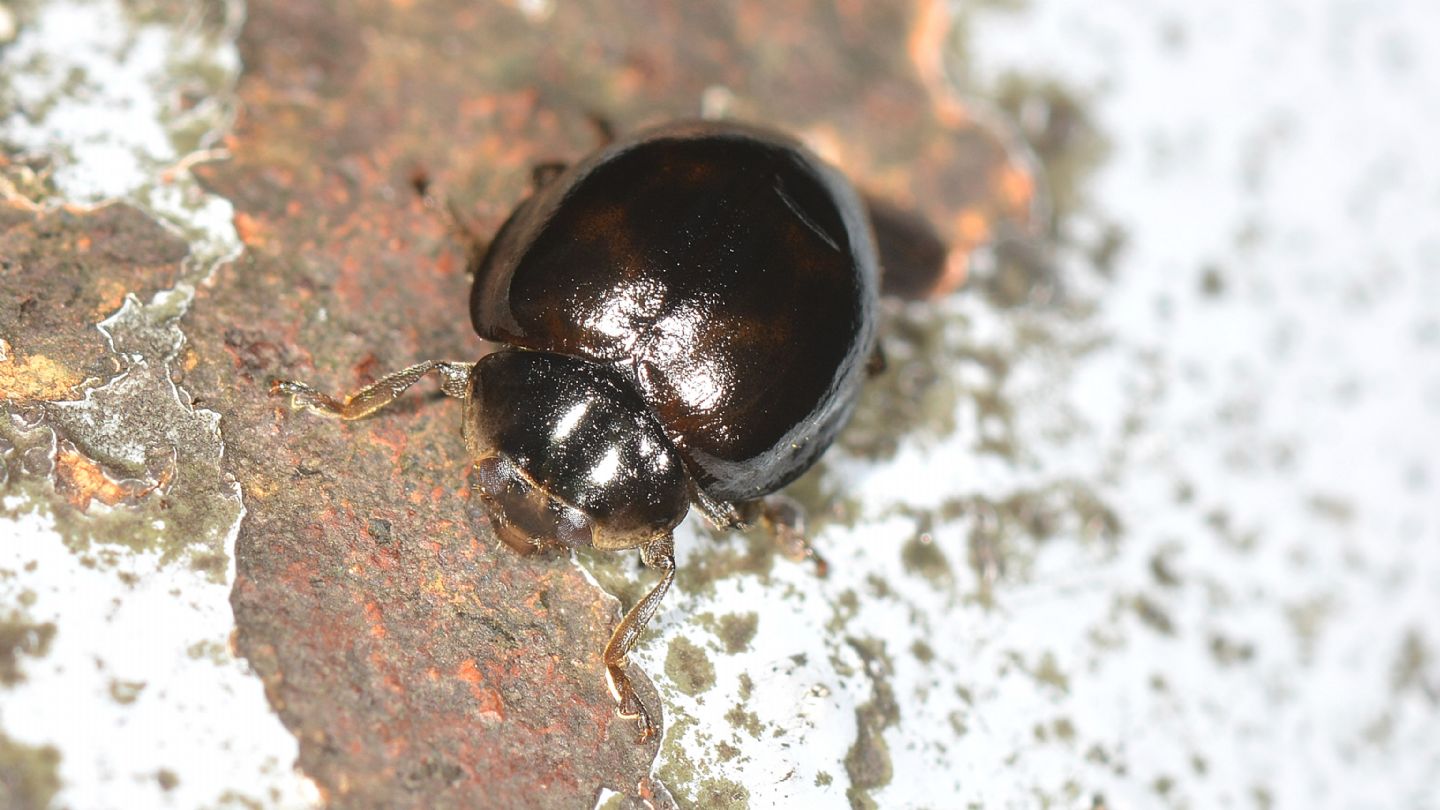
(0, 0, 240, 203)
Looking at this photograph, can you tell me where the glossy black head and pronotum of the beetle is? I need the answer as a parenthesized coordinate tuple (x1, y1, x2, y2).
(465, 349, 690, 549)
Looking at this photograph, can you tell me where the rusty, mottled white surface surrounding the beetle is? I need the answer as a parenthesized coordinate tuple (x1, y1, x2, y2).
(0, 0, 1440, 809)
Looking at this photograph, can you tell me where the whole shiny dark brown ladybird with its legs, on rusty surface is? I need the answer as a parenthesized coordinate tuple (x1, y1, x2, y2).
(272, 123, 878, 739)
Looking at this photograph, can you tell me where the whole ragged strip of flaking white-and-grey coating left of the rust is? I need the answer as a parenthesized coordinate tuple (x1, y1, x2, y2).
(0, 0, 318, 807)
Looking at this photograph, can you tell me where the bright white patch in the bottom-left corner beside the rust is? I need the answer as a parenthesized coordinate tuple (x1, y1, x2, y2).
(0, 515, 317, 807)
